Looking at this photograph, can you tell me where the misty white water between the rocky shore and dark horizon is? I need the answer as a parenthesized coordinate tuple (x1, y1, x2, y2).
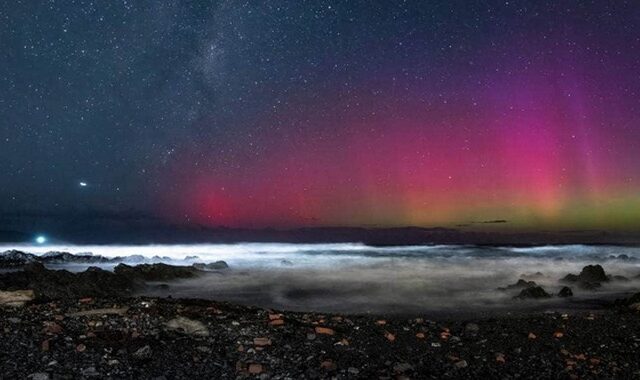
(0, 243, 640, 313)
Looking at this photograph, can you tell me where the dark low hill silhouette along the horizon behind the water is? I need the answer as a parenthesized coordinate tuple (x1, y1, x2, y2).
(0, 221, 640, 246)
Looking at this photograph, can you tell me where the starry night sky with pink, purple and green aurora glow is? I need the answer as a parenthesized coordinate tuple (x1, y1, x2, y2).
(0, 0, 640, 230)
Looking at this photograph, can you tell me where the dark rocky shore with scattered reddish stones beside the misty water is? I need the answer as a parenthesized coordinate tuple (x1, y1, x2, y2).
(0, 251, 640, 379)
